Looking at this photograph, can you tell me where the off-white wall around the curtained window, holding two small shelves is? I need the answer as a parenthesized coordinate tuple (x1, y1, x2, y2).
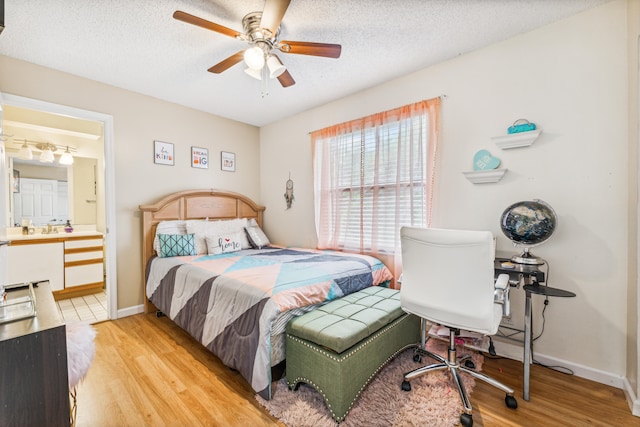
(260, 1, 628, 385)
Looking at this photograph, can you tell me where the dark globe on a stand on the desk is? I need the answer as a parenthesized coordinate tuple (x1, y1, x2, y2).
(500, 199, 558, 264)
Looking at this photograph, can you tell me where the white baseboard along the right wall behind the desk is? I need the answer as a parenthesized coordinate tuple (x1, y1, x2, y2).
(493, 338, 624, 392)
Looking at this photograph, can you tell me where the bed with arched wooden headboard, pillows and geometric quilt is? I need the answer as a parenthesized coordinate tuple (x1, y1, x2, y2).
(140, 190, 392, 399)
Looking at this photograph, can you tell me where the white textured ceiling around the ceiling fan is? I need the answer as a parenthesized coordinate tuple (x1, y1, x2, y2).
(0, 0, 609, 126)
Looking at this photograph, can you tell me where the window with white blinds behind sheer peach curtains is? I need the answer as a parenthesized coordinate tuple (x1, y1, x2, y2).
(312, 98, 440, 254)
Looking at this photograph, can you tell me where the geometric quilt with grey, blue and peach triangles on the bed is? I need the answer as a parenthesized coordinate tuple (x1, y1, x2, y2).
(146, 248, 392, 399)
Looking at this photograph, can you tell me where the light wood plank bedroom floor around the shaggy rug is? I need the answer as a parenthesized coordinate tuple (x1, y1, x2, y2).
(77, 314, 640, 427)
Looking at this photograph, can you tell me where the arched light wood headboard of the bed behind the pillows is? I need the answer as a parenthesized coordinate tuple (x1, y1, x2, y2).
(140, 189, 264, 313)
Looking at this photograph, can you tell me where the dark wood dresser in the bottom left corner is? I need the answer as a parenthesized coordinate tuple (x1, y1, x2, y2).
(0, 282, 70, 427)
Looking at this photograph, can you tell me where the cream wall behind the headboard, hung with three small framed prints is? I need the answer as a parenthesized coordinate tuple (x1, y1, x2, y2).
(0, 56, 260, 310)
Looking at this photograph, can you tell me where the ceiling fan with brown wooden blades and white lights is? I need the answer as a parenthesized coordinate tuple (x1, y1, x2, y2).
(173, 0, 342, 87)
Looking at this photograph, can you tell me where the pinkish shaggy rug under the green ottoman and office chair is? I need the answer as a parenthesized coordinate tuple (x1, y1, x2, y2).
(256, 339, 483, 427)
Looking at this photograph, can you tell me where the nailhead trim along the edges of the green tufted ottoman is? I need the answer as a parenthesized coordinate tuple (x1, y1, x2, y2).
(287, 314, 418, 423)
